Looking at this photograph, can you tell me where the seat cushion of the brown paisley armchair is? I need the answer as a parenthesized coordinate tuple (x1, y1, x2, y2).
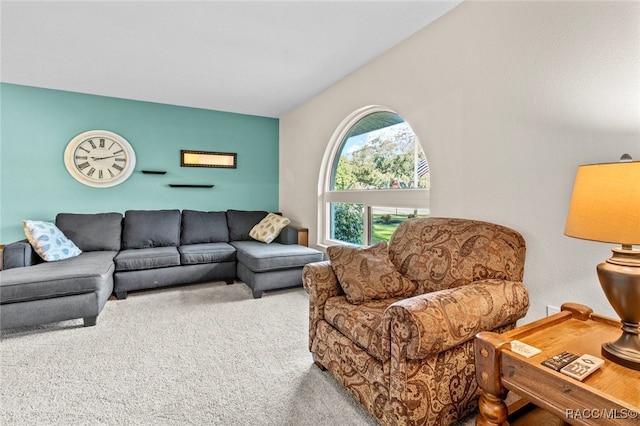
(324, 296, 402, 362)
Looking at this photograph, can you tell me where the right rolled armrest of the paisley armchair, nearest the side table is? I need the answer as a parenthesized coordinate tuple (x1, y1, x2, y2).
(384, 279, 529, 359)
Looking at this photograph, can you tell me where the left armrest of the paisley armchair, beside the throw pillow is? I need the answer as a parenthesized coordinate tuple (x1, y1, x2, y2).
(302, 260, 344, 352)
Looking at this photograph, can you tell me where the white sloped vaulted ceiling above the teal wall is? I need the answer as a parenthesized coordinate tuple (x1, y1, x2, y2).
(0, 0, 461, 117)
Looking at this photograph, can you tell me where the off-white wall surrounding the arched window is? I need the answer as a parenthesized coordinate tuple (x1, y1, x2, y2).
(280, 1, 640, 322)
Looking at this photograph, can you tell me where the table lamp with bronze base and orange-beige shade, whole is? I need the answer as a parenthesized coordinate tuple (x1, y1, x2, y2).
(564, 161, 640, 370)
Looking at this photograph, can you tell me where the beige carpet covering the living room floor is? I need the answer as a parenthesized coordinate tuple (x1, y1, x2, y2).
(0, 282, 473, 426)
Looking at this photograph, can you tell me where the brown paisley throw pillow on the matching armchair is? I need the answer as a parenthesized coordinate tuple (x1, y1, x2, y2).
(327, 241, 416, 304)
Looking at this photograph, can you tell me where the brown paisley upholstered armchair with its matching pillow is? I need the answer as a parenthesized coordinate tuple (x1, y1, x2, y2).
(303, 218, 529, 425)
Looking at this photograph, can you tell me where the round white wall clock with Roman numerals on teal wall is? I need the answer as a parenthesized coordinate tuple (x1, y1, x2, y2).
(64, 130, 136, 188)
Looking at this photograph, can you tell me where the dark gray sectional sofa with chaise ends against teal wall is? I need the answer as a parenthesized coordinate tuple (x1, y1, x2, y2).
(0, 210, 323, 329)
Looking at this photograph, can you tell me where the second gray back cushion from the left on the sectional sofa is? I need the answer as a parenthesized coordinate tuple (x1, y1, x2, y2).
(122, 210, 181, 253)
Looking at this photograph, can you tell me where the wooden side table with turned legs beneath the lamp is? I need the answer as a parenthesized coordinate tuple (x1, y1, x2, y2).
(474, 303, 640, 425)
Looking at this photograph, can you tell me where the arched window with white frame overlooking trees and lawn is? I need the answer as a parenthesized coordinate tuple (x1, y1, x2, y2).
(319, 106, 430, 245)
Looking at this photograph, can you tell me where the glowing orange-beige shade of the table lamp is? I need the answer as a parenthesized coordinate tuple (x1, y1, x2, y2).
(564, 161, 640, 245)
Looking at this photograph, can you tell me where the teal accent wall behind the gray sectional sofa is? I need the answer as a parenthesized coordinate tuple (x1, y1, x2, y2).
(0, 83, 279, 244)
